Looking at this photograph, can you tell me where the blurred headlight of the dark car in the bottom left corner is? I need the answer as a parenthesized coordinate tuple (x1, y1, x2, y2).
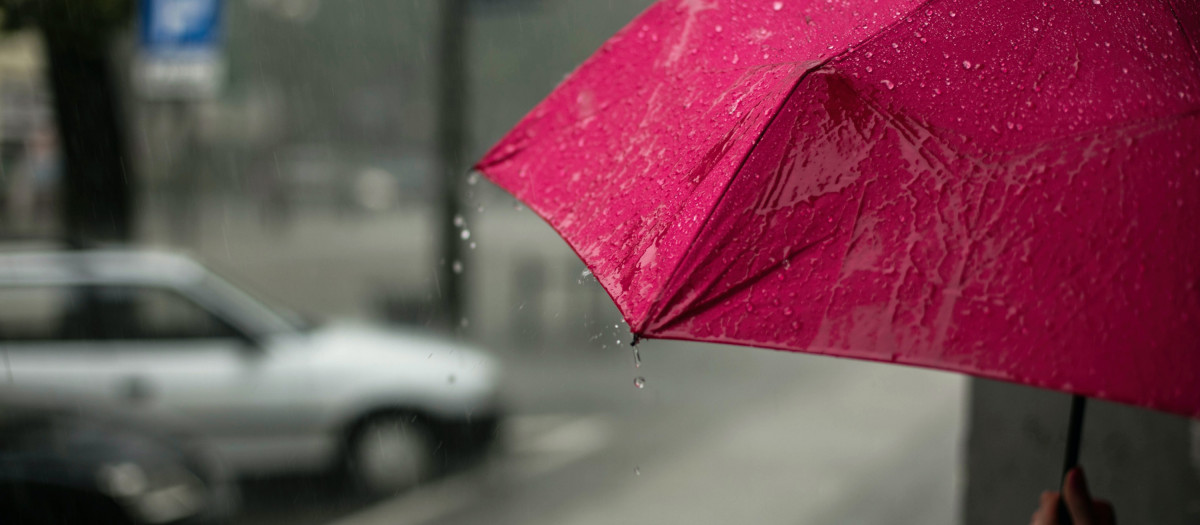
(96, 461, 208, 524)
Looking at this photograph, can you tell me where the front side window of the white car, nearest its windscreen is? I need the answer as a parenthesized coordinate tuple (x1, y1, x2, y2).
(94, 286, 243, 339)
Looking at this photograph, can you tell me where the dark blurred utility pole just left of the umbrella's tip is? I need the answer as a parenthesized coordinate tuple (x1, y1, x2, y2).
(437, 0, 467, 328)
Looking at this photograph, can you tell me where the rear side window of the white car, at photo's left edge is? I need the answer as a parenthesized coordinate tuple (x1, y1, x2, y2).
(0, 286, 97, 342)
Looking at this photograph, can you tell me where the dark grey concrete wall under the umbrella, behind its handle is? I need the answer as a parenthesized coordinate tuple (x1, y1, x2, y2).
(962, 380, 1200, 525)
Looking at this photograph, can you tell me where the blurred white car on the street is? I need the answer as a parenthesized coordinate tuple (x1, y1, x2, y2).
(0, 251, 499, 491)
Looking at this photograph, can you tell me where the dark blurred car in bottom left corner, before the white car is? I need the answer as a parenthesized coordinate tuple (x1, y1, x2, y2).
(0, 388, 238, 525)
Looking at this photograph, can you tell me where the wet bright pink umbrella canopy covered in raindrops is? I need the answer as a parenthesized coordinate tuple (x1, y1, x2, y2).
(479, 0, 1200, 416)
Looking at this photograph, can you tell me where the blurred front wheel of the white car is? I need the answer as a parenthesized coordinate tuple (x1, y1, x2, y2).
(347, 414, 434, 495)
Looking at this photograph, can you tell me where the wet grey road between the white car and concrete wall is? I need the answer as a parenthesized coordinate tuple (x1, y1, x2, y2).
(239, 342, 965, 525)
